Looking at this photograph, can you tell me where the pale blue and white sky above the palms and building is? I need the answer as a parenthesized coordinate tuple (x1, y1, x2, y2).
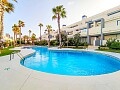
(4, 0, 120, 37)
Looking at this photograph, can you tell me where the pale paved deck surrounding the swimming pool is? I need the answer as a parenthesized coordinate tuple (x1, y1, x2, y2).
(0, 48, 120, 90)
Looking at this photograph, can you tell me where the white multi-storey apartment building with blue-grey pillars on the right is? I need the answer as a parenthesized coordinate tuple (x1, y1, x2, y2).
(41, 5, 120, 46)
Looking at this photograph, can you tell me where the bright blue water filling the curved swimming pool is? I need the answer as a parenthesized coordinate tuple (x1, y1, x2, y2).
(21, 47, 120, 76)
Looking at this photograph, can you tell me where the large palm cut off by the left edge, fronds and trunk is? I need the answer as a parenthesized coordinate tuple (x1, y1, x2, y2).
(0, 0, 17, 41)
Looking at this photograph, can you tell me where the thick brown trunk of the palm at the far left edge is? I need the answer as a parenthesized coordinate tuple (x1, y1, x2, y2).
(0, 4, 4, 41)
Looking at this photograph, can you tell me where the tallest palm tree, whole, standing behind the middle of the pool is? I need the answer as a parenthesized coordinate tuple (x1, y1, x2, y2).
(52, 5, 66, 47)
